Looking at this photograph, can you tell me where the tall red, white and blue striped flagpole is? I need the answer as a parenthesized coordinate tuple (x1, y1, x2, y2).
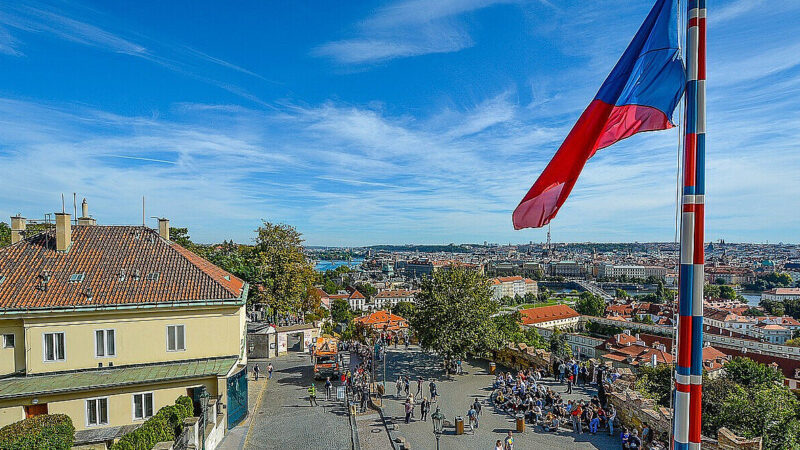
(673, 0, 705, 450)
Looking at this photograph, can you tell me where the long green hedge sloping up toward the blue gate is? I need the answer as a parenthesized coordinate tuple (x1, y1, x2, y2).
(111, 396, 194, 450)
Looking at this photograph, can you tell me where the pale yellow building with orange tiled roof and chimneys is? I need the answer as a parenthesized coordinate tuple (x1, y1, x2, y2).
(0, 209, 248, 443)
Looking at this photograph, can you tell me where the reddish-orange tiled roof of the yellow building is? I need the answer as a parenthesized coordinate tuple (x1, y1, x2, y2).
(0, 225, 245, 310)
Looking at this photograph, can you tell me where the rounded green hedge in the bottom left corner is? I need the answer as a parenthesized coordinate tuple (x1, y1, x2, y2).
(0, 414, 75, 450)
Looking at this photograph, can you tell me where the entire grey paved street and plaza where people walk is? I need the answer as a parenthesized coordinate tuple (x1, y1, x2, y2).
(220, 347, 619, 450)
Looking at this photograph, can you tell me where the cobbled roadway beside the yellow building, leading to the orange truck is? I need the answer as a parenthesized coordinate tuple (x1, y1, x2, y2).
(220, 354, 352, 450)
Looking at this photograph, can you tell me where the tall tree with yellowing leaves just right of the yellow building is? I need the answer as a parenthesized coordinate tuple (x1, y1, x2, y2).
(253, 221, 316, 314)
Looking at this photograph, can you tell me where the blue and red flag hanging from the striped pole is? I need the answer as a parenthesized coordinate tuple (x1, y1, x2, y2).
(513, 0, 686, 230)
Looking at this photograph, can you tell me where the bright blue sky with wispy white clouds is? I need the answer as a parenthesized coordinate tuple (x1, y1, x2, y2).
(0, 0, 800, 245)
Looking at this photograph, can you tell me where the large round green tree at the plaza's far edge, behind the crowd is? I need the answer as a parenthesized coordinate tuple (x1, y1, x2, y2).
(410, 267, 499, 370)
